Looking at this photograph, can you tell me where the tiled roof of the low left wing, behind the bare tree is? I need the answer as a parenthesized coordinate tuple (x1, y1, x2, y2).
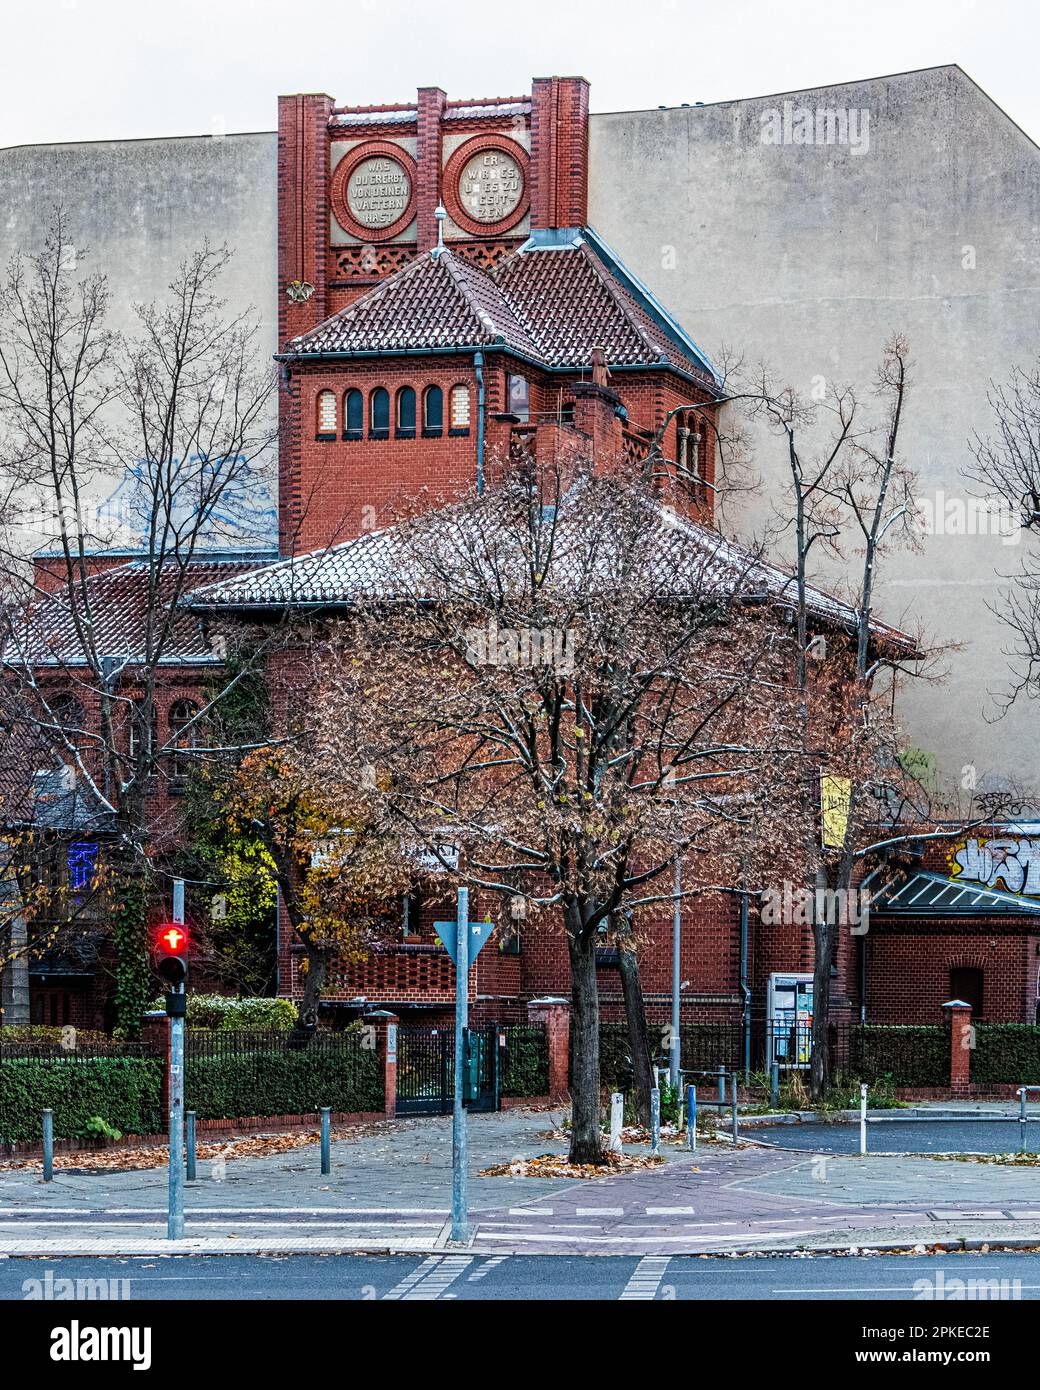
(3, 556, 276, 666)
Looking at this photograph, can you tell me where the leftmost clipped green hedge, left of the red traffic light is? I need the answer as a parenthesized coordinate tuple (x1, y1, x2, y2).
(0, 1056, 163, 1144)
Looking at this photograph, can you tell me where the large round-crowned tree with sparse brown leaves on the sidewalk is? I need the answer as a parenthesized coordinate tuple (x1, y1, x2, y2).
(304, 457, 823, 1162)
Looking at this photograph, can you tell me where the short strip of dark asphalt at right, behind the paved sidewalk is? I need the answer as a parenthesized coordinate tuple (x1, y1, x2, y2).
(747, 1119, 1040, 1154)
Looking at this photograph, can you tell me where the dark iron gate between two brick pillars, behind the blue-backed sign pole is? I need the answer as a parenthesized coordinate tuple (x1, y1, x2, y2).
(398, 1027, 499, 1115)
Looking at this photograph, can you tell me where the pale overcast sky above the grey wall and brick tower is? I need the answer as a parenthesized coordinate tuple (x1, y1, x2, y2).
(0, 0, 1040, 145)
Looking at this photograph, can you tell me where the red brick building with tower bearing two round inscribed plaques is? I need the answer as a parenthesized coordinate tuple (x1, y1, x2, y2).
(8, 78, 1040, 1050)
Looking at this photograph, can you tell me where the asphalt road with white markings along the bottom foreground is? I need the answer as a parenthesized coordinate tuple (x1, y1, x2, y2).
(0, 1252, 1040, 1301)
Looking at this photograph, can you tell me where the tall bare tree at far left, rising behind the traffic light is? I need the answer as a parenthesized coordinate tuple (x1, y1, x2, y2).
(0, 211, 275, 1031)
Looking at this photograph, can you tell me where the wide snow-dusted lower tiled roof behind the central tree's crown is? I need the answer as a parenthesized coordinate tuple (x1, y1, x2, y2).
(185, 491, 915, 655)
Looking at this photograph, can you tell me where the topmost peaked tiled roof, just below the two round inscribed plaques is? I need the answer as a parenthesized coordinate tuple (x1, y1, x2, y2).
(286, 229, 713, 382)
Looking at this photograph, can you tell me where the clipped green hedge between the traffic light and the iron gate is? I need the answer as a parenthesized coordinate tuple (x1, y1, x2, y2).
(185, 1037, 384, 1120)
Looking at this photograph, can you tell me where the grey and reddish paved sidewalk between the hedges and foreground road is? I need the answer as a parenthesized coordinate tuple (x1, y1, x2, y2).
(0, 1111, 1040, 1255)
